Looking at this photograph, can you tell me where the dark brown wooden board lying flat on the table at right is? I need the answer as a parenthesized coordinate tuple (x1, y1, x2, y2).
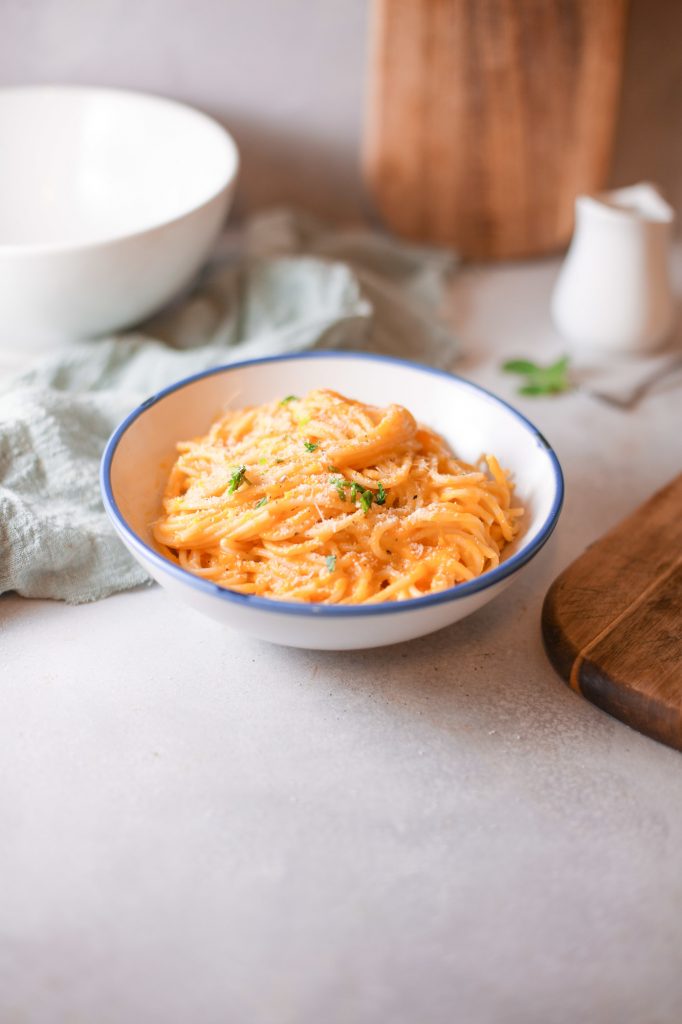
(542, 475, 682, 750)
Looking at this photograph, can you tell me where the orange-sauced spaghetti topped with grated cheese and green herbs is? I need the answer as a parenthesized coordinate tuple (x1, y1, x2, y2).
(154, 390, 523, 604)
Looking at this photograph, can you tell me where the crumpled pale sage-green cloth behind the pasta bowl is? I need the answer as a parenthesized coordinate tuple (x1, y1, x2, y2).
(0, 210, 457, 604)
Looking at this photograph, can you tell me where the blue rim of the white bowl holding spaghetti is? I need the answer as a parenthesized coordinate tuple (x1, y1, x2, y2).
(99, 349, 564, 618)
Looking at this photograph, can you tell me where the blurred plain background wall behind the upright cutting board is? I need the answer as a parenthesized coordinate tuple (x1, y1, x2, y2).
(0, 0, 682, 232)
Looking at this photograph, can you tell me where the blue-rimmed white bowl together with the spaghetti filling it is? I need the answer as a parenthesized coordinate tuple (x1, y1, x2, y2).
(101, 351, 563, 650)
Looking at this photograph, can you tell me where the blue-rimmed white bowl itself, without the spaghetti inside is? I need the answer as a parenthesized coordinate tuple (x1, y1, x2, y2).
(101, 351, 563, 650)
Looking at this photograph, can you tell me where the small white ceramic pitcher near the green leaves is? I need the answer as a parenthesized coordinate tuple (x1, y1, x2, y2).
(552, 182, 676, 354)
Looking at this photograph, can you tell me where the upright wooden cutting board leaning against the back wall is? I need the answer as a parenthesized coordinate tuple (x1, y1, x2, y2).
(365, 0, 627, 259)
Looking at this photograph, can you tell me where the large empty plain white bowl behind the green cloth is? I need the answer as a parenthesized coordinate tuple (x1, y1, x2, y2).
(0, 86, 239, 345)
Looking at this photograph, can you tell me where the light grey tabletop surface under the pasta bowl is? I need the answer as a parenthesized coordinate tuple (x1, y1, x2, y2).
(0, 262, 682, 1024)
